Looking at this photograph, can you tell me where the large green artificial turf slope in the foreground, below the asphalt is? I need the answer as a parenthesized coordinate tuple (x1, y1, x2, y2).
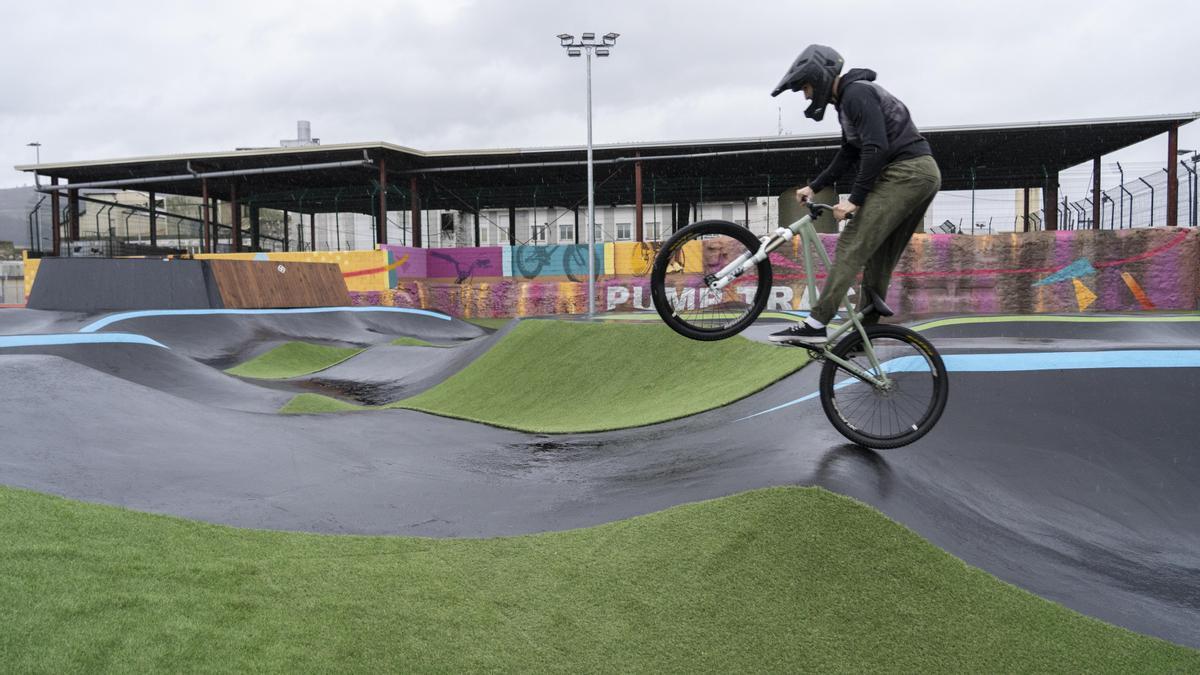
(0, 488, 1200, 673)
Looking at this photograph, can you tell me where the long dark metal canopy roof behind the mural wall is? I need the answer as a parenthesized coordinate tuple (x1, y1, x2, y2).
(17, 113, 1200, 214)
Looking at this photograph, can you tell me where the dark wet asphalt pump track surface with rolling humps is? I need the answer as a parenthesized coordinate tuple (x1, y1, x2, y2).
(0, 310, 1200, 647)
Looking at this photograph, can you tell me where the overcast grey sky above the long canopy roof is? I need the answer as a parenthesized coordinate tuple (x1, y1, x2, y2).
(0, 0, 1200, 193)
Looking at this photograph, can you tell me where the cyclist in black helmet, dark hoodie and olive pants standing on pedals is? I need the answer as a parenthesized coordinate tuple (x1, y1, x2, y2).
(770, 44, 942, 346)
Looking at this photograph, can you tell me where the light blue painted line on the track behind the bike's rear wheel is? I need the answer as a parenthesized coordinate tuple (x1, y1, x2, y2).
(736, 350, 1200, 422)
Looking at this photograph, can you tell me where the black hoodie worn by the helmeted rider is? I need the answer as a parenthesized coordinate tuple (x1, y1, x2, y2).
(809, 68, 934, 207)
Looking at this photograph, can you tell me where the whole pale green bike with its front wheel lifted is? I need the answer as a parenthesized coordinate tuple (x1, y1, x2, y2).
(650, 203, 949, 449)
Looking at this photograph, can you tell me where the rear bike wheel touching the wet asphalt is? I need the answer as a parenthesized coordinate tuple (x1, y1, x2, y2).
(821, 324, 950, 450)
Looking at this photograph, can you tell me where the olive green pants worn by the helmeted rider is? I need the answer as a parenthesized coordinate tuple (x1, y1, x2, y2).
(812, 155, 942, 323)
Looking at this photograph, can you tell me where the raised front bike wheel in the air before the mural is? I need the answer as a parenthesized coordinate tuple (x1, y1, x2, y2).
(650, 220, 772, 340)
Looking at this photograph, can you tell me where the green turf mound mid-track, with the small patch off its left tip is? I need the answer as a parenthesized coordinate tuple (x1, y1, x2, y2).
(281, 321, 808, 434)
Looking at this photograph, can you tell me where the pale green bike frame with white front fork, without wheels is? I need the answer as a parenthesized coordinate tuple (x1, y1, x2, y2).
(704, 204, 892, 389)
